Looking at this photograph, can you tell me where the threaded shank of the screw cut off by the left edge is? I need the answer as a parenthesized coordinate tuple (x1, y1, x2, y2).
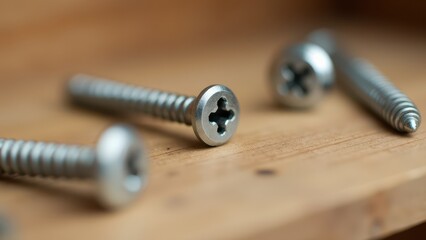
(0, 139, 96, 178)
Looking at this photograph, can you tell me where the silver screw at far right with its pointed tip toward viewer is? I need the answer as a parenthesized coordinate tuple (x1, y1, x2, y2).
(309, 30, 421, 133)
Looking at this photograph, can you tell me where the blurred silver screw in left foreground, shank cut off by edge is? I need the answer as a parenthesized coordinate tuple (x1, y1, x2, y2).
(0, 125, 148, 209)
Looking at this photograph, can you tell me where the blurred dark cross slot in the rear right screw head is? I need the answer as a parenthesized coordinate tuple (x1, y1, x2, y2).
(281, 63, 311, 96)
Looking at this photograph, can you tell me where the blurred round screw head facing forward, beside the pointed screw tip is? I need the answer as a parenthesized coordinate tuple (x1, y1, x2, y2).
(270, 43, 334, 108)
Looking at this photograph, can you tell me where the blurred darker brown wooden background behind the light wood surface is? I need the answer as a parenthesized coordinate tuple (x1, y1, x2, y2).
(0, 0, 426, 79)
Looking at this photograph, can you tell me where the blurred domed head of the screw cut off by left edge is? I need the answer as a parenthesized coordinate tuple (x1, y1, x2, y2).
(95, 125, 148, 209)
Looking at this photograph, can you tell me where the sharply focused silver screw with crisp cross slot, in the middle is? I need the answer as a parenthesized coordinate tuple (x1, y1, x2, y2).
(68, 74, 240, 146)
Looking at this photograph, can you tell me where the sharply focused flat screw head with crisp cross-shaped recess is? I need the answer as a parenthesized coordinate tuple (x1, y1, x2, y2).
(192, 85, 240, 146)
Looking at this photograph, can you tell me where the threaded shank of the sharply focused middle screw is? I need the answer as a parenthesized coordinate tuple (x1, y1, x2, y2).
(68, 75, 195, 125)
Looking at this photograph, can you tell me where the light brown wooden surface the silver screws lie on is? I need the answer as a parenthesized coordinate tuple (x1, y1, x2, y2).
(0, 16, 426, 240)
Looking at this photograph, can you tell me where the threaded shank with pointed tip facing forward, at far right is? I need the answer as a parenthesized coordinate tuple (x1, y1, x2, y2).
(338, 59, 421, 132)
